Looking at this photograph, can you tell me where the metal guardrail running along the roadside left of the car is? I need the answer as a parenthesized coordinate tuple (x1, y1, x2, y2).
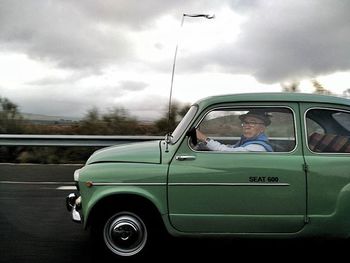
(0, 134, 164, 147)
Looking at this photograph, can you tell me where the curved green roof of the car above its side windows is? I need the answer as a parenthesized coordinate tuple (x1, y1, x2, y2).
(196, 92, 350, 108)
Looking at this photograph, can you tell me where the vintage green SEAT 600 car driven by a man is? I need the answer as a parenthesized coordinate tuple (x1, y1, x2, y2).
(66, 93, 350, 257)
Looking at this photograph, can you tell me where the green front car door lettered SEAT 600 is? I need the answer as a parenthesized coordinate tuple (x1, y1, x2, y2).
(168, 103, 306, 233)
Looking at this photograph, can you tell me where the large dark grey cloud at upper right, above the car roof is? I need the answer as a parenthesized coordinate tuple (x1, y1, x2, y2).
(184, 0, 350, 83)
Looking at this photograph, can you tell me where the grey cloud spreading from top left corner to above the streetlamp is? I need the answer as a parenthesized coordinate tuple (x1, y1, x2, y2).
(0, 0, 219, 74)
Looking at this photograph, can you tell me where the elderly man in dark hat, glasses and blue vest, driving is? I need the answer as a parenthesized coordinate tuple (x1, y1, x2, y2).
(196, 110, 273, 152)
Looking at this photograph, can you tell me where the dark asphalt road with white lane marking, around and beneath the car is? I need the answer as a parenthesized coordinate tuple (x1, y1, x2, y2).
(0, 164, 350, 263)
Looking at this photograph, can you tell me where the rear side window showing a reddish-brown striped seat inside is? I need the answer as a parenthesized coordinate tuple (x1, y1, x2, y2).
(306, 109, 350, 153)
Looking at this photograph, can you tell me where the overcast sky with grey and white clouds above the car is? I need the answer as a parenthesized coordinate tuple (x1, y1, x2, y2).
(0, 0, 350, 119)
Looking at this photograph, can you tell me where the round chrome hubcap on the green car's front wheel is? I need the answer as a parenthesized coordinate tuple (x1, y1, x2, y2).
(103, 213, 147, 256)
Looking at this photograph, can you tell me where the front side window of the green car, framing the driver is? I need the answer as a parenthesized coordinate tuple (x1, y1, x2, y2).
(193, 107, 296, 152)
